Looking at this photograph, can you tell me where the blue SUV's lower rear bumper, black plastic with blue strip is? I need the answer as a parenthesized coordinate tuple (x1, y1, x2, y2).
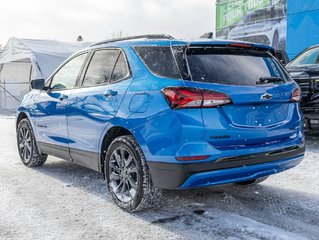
(148, 145, 305, 189)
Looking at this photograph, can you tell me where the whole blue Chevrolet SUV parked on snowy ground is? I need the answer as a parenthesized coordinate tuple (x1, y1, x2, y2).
(16, 35, 305, 211)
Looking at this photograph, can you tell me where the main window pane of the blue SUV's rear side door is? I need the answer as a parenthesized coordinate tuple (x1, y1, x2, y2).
(83, 49, 120, 86)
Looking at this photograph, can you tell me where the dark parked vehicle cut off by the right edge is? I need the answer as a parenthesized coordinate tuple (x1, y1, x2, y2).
(286, 45, 319, 132)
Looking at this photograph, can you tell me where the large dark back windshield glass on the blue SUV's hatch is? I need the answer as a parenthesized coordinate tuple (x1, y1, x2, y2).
(187, 48, 286, 86)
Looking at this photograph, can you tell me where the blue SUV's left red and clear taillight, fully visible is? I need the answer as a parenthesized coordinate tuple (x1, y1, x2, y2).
(162, 87, 231, 109)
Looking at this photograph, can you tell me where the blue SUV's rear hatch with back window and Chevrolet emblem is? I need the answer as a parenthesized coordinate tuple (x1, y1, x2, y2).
(178, 44, 301, 148)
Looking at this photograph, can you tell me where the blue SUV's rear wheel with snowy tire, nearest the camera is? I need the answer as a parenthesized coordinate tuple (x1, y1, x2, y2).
(104, 135, 161, 212)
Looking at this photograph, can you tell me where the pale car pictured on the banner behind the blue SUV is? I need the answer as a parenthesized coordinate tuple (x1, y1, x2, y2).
(228, 7, 286, 49)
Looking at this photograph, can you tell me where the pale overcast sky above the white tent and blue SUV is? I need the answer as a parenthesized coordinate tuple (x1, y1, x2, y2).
(0, 0, 215, 45)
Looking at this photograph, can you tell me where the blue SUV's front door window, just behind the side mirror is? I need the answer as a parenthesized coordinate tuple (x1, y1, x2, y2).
(51, 53, 87, 90)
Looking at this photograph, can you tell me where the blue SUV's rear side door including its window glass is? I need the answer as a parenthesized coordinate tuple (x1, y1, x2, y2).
(67, 49, 132, 170)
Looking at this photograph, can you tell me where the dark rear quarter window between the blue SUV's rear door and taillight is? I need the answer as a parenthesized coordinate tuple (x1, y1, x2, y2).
(135, 46, 181, 78)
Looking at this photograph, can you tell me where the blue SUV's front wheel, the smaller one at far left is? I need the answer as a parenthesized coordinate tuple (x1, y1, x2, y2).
(17, 118, 48, 167)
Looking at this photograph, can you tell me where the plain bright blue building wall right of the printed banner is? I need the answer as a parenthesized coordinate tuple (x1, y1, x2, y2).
(287, 0, 319, 59)
